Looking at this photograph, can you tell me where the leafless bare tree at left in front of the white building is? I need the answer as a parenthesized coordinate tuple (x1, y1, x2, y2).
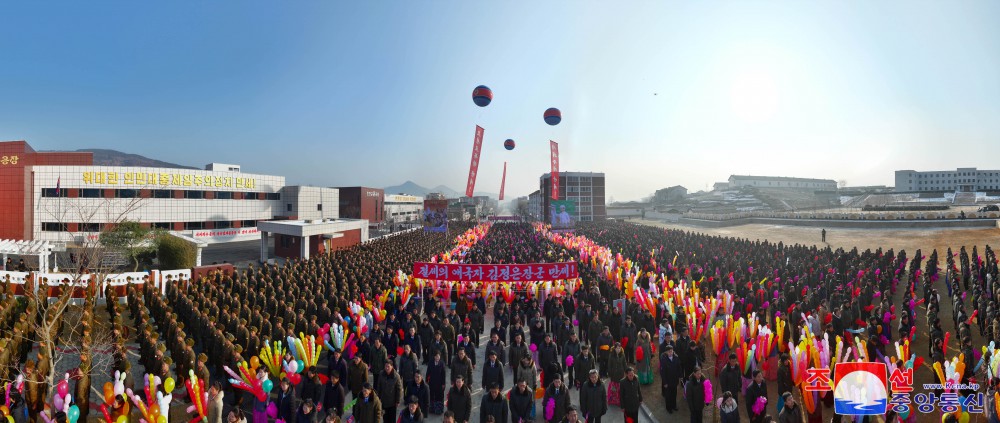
(20, 196, 151, 416)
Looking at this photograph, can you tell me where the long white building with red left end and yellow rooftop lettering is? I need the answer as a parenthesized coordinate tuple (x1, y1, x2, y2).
(0, 141, 368, 250)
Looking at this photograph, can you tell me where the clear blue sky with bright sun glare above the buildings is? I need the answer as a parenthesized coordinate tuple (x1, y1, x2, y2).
(0, 0, 1000, 200)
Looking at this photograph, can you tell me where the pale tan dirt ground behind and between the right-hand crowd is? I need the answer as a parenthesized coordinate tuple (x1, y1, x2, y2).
(634, 220, 1000, 422)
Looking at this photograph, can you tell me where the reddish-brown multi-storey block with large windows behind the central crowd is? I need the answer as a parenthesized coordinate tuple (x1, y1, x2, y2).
(540, 172, 608, 222)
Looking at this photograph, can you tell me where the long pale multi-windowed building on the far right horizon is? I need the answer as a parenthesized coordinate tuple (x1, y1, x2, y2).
(896, 167, 1000, 192)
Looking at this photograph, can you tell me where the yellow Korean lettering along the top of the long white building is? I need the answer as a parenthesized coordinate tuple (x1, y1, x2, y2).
(82, 172, 257, 189)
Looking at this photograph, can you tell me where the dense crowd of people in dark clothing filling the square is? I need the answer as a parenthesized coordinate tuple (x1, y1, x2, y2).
(0, 222, 1000, 423)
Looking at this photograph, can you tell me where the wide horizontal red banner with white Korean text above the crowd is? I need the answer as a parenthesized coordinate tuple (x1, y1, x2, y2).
(413, 262, 579, 282)
